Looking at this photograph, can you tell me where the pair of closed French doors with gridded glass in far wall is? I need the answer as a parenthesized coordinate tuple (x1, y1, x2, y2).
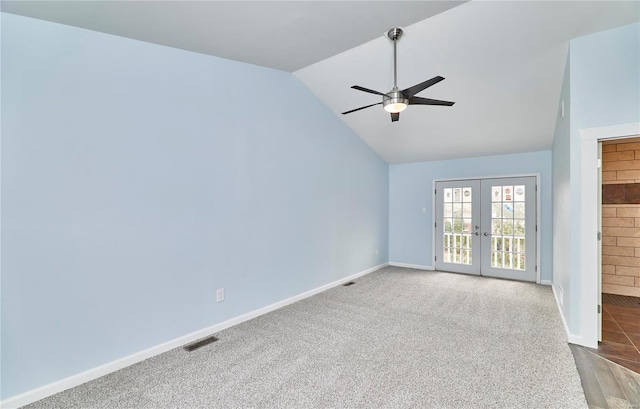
(435, 177, 537, 281)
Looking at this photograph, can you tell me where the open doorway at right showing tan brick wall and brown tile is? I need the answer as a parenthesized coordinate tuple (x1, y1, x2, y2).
(597, 137, 640, 373)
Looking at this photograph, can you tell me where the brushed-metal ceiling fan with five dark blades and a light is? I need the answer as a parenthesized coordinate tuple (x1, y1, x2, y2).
(342, 27, 455, 122)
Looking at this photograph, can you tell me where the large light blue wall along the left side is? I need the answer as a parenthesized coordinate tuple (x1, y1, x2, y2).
(2, 14, 389, 398)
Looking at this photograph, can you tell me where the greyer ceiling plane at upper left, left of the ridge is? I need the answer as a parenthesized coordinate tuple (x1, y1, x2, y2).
(2, 0, 466, 72)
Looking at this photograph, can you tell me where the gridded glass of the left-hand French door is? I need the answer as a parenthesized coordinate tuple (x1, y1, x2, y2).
(442, 187, 473, 265)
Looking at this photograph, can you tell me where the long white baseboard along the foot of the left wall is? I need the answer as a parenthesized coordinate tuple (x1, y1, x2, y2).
(0, 263, 389, 409)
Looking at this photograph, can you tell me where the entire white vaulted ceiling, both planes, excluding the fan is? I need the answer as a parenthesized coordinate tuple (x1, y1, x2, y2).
(2, 0, 640, 163)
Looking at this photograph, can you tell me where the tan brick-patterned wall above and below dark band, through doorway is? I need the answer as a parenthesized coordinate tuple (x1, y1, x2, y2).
(602, 138, 640, 297)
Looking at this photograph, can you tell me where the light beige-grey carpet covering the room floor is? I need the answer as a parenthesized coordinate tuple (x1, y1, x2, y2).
(23, 267, 587, 408)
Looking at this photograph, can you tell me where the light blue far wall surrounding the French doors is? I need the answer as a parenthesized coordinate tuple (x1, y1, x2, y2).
(389, 151, 552, 280)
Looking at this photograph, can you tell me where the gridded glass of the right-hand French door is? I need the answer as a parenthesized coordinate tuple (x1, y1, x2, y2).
(491, 185, 526, 270)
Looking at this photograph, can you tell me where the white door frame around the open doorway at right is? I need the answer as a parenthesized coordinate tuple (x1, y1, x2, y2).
(570, 122, 640, 348)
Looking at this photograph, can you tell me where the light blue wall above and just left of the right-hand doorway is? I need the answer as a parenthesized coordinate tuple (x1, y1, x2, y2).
(569, 23, 640, 334)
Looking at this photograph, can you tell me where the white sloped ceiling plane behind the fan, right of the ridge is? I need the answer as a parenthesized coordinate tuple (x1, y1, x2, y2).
(295, 1, 640, 163)
